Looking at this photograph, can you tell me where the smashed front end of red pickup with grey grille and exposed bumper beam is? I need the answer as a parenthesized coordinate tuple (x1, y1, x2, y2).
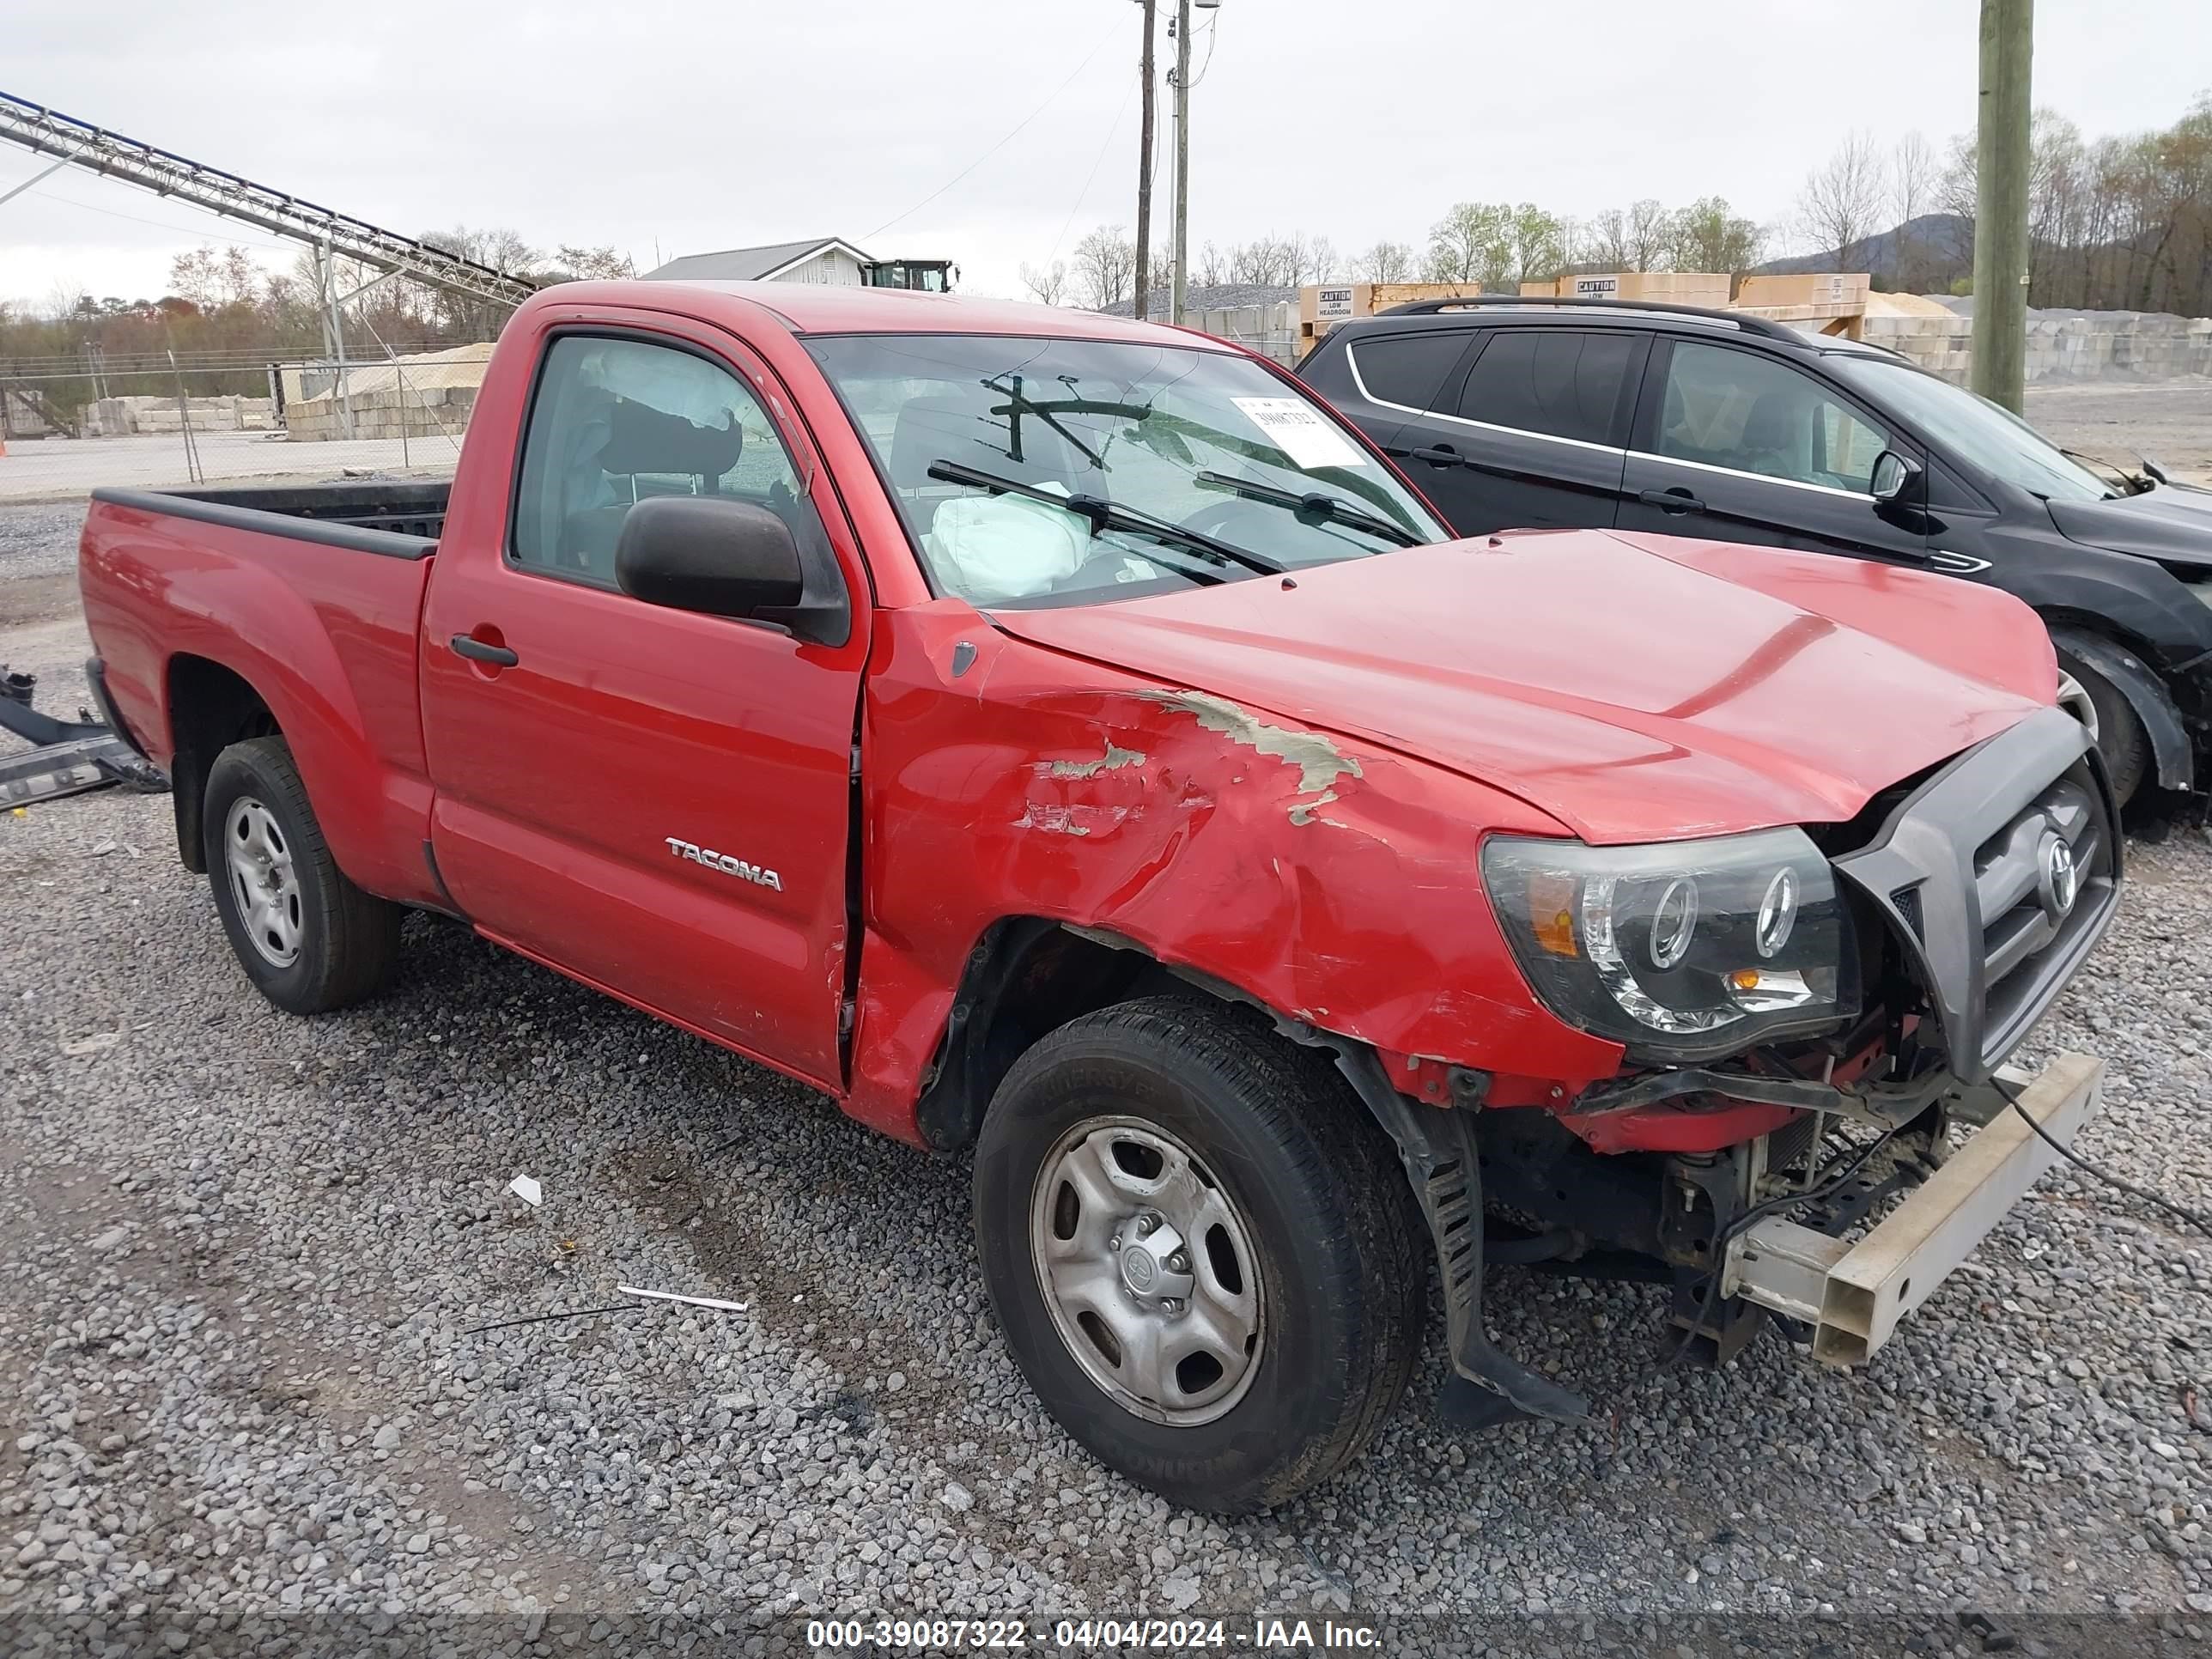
(1343, 710, 2121, 1418)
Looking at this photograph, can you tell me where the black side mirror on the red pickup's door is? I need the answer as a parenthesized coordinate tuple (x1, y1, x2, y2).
(615, 495, 805, 623)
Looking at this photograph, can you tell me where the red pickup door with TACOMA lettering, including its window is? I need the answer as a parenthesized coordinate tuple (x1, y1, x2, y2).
(422, 314, 867, 1084)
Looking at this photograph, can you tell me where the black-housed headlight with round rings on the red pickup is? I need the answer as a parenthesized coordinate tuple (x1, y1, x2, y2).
(1482, 830, 1858, 1060)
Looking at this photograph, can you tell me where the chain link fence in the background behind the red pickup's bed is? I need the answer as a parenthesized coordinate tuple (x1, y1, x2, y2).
(0, 343, 491, 502)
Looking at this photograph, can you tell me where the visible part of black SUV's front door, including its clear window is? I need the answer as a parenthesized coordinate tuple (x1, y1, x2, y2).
(1620, 341, 1927, 564)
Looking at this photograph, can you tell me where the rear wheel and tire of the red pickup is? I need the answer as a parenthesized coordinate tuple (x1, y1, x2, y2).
(199, 737, 404, 1013)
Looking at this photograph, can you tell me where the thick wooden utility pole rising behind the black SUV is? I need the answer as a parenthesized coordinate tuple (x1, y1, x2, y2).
(1973, 0, 2035, 414)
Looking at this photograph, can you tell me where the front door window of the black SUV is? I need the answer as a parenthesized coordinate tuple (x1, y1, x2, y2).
(1656, 341, 1889, 493)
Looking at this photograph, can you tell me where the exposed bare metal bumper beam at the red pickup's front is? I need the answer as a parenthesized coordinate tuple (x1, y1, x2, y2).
(1723, 1053, 2104, 1367)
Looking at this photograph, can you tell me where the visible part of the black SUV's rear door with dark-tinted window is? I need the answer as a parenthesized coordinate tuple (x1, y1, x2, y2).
(1380, 325, 1646, 535)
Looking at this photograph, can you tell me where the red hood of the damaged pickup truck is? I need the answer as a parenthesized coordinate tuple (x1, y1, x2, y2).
(994, 531, 2055, 842)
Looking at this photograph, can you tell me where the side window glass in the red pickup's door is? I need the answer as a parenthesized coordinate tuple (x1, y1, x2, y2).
(511, 334, 814, 586)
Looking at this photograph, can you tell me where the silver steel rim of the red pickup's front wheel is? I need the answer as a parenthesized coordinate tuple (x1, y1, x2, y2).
(1029, 1117, 1267, 1427)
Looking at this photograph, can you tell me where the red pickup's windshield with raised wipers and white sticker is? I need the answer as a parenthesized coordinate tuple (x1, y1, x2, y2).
(807, 334, 1451, 606)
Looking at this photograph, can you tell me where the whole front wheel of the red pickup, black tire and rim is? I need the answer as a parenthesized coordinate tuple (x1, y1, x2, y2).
(975, 998, 1427, 1513)
